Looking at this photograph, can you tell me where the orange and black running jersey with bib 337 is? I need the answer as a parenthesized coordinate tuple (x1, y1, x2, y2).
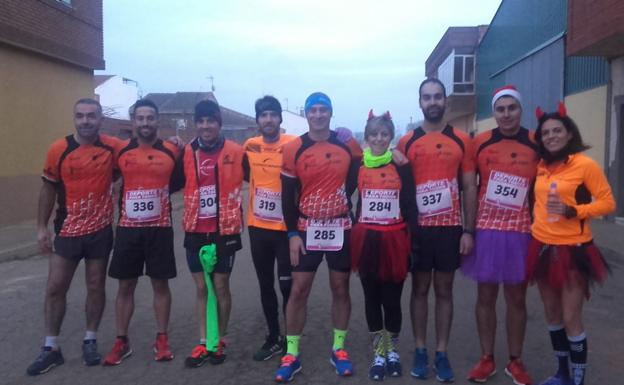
(397, 125, 475, 226)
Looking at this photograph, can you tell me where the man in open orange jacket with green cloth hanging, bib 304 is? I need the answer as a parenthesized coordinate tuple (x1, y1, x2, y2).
(178, 100, 243, 368)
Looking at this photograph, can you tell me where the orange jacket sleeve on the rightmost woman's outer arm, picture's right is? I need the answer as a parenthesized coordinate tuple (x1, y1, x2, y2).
(572, 160, 615, 219)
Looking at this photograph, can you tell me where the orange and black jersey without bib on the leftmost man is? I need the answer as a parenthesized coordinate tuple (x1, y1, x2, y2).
(42, 135, 122, 237)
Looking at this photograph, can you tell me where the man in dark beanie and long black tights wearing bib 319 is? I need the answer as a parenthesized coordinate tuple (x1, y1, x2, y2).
(243, 95, 295, 361)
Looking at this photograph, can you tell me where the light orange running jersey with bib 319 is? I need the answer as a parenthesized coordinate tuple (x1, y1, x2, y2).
(243, 134, 296, 231)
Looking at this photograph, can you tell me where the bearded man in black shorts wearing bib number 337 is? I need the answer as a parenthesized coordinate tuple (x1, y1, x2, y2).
(398, 78, 476, 382)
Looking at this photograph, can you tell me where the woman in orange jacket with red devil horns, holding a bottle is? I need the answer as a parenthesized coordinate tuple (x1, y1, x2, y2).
(527, 103, 615, 385)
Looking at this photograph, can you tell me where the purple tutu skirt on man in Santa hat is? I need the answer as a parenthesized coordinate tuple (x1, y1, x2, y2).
(461, 230, 531, 285)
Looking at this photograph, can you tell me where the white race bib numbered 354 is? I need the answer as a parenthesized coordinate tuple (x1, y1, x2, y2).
(485, 171, 529, 211)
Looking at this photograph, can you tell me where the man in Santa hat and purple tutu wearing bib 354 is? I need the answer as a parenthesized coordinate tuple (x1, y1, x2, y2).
(462, 85, 540, 385)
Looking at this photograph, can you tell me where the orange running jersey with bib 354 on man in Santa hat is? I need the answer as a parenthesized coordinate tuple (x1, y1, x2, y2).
(474, 127, 539, 233)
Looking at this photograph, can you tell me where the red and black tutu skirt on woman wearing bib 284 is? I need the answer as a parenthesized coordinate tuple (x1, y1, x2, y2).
(351, 223, 411, 282)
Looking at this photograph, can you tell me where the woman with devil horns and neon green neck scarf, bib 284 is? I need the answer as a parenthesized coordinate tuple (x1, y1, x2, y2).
(351, 110, 418, 381)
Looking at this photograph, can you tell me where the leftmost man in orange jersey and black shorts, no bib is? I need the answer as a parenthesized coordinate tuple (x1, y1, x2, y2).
(27, 99, 120, 375)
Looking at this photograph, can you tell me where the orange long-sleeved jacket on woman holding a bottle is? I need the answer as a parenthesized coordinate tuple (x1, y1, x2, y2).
(531, 153, 615, 245)
